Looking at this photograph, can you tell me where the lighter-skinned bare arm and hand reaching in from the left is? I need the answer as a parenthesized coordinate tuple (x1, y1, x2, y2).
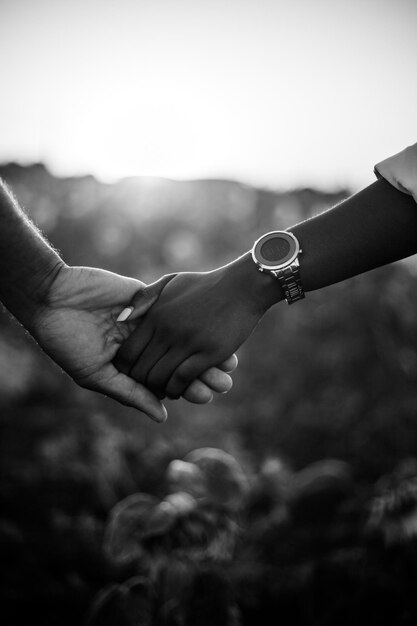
(0, 181, 234, 421)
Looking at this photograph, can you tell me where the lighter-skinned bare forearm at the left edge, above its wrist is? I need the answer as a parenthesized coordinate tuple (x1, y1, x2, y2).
(0, 180, 64, 326)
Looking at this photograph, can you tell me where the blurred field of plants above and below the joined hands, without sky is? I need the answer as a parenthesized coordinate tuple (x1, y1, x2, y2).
(0, 164, 417, 626)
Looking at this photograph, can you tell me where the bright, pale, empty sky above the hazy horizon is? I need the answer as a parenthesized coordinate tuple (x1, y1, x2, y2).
(0, 0, 417, 189)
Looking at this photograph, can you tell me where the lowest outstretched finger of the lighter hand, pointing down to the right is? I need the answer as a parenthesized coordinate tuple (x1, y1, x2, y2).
(96, 372, 168, 423)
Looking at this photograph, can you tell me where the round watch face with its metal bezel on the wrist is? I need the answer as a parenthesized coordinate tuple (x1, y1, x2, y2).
(252, 231, 300, 269)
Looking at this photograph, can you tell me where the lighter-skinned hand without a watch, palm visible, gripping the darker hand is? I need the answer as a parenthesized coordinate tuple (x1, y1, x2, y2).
(27, 266, 235, 422)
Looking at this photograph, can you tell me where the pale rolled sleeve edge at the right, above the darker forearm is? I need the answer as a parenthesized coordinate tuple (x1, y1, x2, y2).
(374, 143, 417, 202)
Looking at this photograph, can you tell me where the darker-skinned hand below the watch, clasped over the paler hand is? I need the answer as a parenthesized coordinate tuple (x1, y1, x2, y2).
(114, 257, 272, 398)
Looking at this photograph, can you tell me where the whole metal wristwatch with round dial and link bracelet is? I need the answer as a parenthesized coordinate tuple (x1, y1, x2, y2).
(252, 230, 305, 304)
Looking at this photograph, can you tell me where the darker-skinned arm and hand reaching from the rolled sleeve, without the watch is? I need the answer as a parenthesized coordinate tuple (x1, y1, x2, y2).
(116, 180, 417, 397)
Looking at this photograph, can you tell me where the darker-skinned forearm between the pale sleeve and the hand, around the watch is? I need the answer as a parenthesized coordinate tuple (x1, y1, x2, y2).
(231, 180, 417, 309)
